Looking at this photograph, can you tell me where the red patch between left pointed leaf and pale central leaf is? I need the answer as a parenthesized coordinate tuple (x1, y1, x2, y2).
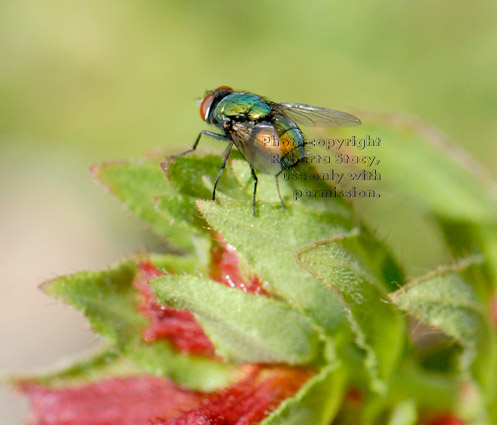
(133, 261, 214, 357)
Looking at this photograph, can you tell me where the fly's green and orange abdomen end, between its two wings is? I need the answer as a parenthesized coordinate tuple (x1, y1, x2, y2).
(273, 116, 305, 168)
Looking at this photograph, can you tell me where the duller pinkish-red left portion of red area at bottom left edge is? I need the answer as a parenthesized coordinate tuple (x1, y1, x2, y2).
(21, 376, 202, 425)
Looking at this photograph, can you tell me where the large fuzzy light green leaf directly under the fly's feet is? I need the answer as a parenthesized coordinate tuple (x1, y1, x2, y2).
(197, 201, 352, 342)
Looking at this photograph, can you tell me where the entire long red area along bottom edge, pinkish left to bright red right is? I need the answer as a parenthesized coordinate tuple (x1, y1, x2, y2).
(20, 366, 310, 425)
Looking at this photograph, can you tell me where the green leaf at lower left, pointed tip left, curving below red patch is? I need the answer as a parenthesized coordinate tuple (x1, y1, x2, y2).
(43, 256, 233, 389)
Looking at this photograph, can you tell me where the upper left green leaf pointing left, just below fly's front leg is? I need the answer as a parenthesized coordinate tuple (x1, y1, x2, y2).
(92, 160, 194, 252)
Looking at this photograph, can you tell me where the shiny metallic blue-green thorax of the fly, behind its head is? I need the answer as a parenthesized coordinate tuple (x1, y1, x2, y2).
(213, 93, 271, 122)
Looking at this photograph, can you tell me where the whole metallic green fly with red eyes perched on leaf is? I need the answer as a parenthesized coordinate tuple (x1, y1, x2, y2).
(173, 86, 361, 215)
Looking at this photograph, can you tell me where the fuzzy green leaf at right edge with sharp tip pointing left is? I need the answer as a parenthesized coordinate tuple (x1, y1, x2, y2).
(390, 259, 496, 388)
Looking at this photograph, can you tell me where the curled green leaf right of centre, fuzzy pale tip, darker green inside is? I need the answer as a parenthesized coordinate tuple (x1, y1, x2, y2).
(297, 232, 404, 394)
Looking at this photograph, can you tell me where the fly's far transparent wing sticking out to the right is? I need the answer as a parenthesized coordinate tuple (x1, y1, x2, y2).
(271, 103, 361, 127)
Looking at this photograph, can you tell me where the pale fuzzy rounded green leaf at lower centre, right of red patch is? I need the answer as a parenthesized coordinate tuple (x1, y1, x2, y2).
(151, 276, 318, 364)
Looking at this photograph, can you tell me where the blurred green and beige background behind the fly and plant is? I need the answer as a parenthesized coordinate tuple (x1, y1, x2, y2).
(0, 0, 497, 423)
